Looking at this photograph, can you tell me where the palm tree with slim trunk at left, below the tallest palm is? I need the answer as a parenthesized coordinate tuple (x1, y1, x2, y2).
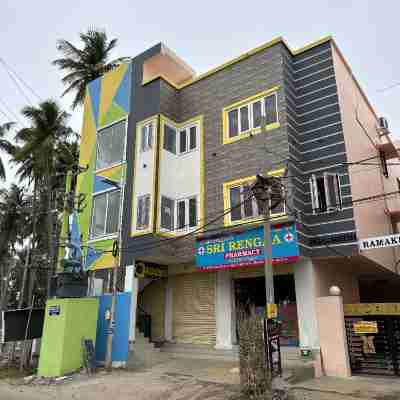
(14, 100, 73, 294)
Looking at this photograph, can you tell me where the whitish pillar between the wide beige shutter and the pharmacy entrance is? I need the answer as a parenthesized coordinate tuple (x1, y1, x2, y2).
(215, 271, 232, 350)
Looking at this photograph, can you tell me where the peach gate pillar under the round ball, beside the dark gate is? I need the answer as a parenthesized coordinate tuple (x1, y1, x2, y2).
(316, 296, 351, 378)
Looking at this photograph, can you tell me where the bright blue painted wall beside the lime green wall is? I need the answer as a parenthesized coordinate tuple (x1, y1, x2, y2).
(96, 293, 132, 362)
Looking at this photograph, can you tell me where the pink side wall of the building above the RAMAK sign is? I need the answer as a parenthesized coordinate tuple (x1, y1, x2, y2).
(332, 42, 400, 271)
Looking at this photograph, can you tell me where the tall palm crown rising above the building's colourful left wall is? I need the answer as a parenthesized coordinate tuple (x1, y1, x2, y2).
(53, 28, 129, 109)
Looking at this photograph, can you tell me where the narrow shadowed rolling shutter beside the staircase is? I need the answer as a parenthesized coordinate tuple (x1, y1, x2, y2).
(138, 279, 166, 342)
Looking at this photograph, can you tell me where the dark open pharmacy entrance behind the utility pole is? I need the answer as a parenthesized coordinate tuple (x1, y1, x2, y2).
(234, 274, 299, 346)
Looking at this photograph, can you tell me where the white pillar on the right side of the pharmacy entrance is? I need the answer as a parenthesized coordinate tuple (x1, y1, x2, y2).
(294, 258, 319, 350)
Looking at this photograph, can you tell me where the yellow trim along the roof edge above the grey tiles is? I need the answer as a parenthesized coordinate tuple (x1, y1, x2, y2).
(143, 36, 333, 89)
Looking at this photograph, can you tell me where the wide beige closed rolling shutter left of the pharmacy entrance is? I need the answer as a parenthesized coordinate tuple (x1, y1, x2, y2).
(171, 272, 216, 344)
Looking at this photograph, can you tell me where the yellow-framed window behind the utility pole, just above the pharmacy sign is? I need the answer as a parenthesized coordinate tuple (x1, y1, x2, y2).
(224, 169, 286, 225)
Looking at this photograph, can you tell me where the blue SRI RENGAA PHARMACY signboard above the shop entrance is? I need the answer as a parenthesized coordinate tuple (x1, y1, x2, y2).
(196, 225, 299, 271)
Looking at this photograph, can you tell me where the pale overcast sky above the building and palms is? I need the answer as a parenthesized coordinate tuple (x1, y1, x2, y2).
(0, 0, 400, 188)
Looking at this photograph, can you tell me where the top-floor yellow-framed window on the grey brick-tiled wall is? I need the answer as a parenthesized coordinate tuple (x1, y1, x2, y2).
(222, 86, 280, 144)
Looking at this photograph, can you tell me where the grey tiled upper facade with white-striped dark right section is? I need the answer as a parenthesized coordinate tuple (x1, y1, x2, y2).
(122, 42, 355, 265)
